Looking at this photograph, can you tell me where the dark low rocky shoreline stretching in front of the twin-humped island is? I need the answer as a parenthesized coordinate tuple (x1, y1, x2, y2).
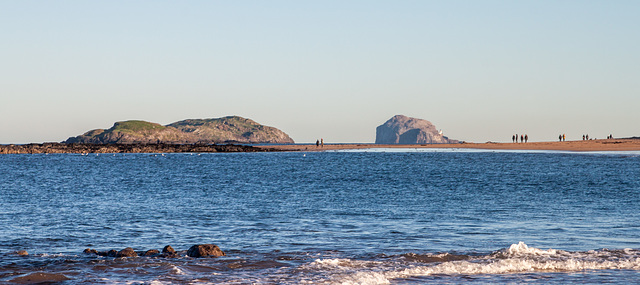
(0, 143, 281, 154)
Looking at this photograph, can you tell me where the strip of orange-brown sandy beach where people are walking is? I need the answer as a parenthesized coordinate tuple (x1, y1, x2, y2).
(258, 139, 640, 151)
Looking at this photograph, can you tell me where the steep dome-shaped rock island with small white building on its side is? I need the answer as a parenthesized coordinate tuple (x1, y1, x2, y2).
(376, 115, 459, 144)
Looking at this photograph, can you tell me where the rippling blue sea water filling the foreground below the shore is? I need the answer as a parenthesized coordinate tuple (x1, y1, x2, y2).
(0, 148, 640, 284)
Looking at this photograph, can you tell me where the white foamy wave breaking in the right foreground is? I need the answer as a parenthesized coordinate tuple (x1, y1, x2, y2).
(309, 242, 640, 284)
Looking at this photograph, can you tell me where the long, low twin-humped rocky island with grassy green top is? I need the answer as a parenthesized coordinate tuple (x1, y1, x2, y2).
(65, 116, 294, 144)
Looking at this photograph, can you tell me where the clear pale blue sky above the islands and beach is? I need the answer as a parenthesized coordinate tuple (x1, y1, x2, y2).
(0, 0, 640, 144)
